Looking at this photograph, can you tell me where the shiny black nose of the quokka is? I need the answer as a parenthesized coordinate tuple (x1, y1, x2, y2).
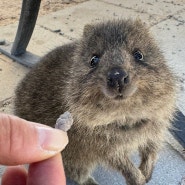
(107, 68, 129, 92)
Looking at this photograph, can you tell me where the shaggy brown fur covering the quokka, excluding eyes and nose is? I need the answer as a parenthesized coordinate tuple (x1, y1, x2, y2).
(15, 20, 176, 185)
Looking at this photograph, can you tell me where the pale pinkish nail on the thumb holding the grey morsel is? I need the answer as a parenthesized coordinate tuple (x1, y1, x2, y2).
(37, 127, 68, 153)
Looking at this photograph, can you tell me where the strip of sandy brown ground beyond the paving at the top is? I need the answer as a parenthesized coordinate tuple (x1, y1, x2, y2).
(0, 0, 86, 26)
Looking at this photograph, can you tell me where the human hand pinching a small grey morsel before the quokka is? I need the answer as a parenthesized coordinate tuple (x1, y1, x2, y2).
(0, 114, 68, 185)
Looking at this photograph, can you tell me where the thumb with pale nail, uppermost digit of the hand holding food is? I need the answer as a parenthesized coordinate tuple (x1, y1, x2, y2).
(0, 114, 68, 165)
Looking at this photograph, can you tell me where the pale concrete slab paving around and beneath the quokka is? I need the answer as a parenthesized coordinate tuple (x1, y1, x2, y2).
(0, 0, 185, 185)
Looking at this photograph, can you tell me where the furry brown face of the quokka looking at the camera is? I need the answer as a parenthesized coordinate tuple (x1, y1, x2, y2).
(72, 21, 173, 101)
